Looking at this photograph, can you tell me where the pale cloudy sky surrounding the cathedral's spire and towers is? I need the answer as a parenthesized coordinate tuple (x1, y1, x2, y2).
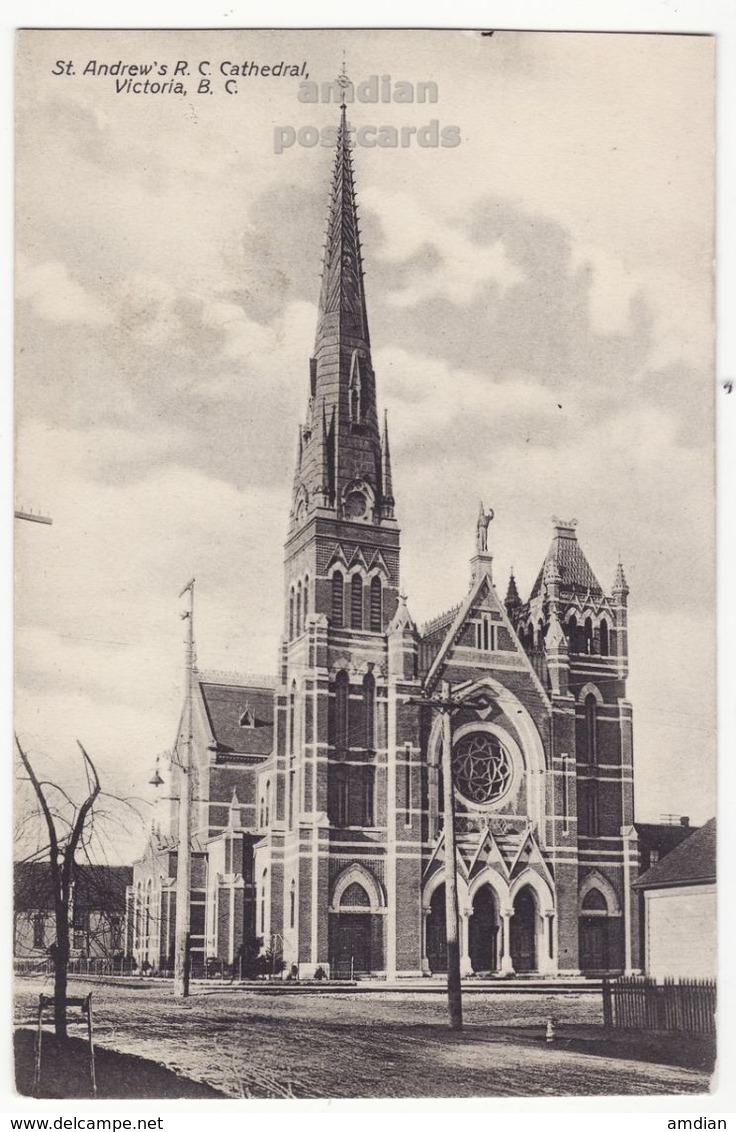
(16, 31, 716, 855)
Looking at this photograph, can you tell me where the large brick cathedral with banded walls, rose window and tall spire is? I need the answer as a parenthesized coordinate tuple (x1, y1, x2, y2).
(128, 108, 642, 978)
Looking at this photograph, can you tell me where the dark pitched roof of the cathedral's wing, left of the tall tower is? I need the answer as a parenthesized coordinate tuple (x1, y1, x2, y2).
(199, 678, 274, 758)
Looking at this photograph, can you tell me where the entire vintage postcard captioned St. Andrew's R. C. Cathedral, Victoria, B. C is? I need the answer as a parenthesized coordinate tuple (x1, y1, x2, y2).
(14, 29, 717, 1104)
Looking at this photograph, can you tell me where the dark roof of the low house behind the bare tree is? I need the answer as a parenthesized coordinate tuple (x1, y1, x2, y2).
(12, 860, 132, 912)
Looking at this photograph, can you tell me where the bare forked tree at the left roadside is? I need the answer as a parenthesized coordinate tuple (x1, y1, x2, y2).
(16, 736, 102, 1040)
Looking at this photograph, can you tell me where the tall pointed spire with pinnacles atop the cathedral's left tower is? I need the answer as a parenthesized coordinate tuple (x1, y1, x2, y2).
(291, 103, 394, 532)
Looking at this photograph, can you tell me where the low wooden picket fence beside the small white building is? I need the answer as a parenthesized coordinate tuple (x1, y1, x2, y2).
(602, 977, 716, 1034)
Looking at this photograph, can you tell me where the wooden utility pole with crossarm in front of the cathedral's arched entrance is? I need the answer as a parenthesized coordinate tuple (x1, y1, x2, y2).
(411, 680, 467, 1030)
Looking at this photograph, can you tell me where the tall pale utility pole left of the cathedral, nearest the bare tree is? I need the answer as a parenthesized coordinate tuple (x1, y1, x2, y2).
(173, 577, 195, 998)
